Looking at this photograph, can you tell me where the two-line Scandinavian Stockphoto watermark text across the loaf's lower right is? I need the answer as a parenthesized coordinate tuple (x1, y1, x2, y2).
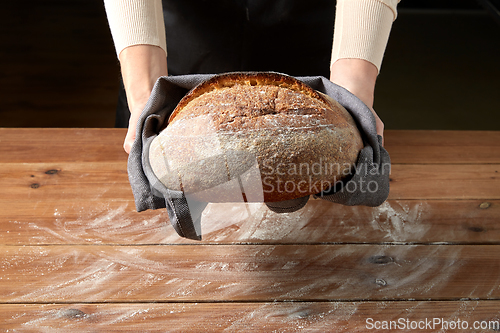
(261, 159, 391, 193)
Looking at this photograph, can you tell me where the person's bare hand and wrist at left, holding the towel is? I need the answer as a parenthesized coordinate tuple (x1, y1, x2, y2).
(120, 45, 168, 154)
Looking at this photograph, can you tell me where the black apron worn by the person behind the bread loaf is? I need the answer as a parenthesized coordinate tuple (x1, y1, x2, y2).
(116, 0, 335, 127)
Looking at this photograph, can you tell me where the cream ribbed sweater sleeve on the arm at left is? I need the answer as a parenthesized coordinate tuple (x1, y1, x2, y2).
(104, 0, 167, 56)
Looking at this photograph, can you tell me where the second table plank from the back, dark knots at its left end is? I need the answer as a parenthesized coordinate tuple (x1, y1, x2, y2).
(0, 161, 500, 202)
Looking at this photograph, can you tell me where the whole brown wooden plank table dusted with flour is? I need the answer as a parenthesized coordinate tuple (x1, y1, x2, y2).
(0, 129, 500, 332)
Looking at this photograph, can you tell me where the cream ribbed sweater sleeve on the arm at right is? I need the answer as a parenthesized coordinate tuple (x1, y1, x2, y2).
(331, 0, 400, 71)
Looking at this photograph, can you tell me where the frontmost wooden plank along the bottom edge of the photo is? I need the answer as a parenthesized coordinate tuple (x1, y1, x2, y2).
(0, 301, 500, 333)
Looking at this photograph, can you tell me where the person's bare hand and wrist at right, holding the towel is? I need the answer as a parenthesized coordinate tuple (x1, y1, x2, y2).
(330, 59, 384, 142)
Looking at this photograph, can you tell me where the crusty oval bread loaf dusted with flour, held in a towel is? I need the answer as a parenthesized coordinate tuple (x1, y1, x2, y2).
(149, 72, 363, 202)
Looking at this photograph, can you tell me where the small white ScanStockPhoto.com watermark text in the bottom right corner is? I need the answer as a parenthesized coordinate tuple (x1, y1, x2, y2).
(365, 318, 500, 331)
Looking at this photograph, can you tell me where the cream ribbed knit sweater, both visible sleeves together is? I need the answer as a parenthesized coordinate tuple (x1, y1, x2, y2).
(104, 0, 400, 70)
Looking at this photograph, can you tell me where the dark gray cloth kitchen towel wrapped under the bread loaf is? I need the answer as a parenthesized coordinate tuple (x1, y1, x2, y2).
(128, 74, 391, 240)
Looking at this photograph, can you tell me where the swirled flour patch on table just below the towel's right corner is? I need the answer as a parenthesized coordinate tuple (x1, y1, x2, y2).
(370, 201, 431, 242)
